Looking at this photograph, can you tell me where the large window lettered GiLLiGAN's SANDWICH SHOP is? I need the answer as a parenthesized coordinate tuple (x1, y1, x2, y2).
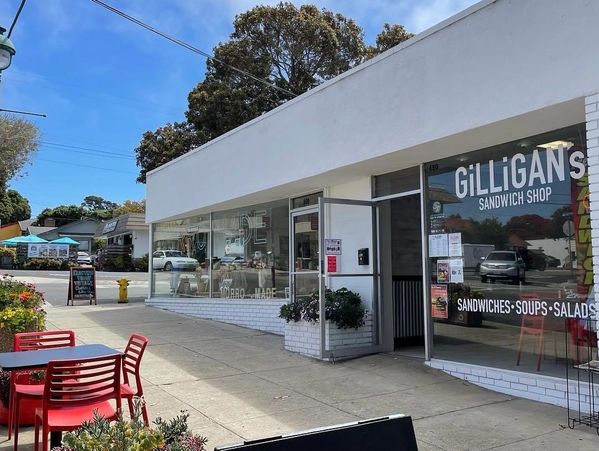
(427, 125, 596, 376)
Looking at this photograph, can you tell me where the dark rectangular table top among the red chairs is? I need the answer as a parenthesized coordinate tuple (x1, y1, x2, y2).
(0, 344, 122, 371)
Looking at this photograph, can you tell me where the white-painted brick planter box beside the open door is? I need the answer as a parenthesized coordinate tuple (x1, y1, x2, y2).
(285, 313, 372, 358)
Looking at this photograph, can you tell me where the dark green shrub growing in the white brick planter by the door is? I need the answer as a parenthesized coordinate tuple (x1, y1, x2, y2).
(279, 288, 366, 329)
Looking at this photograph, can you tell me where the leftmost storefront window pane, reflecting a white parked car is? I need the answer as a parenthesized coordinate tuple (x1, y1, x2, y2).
(152, 216, 210, 297)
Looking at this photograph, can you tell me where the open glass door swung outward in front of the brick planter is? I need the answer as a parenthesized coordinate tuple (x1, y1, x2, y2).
(319, 198, 382, 359)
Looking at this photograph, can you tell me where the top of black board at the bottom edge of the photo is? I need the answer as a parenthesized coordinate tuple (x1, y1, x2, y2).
(214, 415, 418, 451)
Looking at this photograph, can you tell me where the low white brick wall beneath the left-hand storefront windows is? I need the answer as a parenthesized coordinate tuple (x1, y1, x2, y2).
(146, 298, 287, 335)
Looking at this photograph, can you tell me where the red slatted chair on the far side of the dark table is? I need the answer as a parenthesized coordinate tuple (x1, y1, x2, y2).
(8, 330, 75, 451)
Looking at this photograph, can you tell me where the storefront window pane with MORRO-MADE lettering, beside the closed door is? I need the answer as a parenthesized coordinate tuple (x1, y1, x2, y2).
(212, 200, 289, 299)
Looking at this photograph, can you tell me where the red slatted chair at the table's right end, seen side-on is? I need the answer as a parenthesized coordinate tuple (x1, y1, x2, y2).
(121, 333, 150, 426)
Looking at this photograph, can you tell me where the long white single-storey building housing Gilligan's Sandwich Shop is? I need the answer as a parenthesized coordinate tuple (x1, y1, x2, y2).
(146, 0, 599, 414)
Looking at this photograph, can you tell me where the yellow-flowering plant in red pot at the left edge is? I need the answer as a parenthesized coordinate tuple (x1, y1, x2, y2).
(0, 275, 46, 424)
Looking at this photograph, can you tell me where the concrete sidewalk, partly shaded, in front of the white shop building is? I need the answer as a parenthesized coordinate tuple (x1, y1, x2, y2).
(0, 304, 599, 450)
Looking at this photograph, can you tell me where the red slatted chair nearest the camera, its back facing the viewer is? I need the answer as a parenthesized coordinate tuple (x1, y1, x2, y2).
(34, 354, 121, 451)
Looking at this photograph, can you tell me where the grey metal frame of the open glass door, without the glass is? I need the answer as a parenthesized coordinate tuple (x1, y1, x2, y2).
(318, 197, 383, 359)
